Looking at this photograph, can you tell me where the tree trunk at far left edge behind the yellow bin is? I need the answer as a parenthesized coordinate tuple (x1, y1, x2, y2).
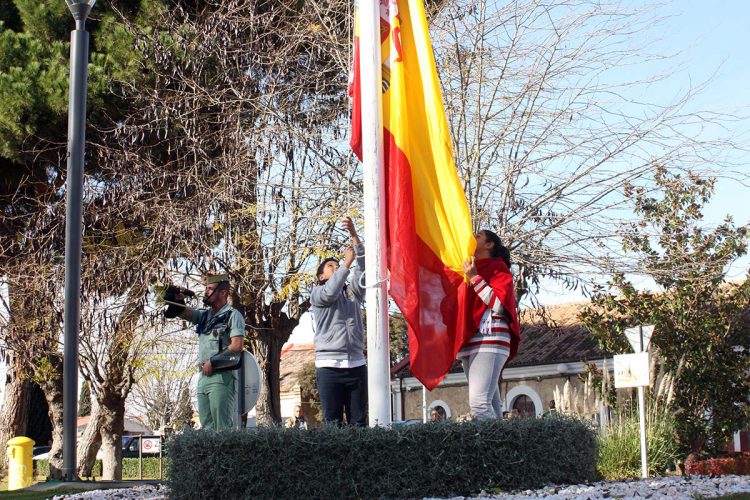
(0, 351, 31, 475)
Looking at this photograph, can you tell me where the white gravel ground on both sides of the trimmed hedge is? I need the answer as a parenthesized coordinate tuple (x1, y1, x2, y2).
(53, 476, 750, 500)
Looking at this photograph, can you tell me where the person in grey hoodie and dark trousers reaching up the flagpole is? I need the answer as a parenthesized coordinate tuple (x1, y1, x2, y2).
(310, 218, 367, 426)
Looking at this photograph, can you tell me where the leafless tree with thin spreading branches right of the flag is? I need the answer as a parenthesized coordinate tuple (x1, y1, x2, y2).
(432, 0, 746, 298)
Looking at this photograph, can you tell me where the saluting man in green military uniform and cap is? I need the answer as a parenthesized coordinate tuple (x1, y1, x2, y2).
(175, 274, 245, 431)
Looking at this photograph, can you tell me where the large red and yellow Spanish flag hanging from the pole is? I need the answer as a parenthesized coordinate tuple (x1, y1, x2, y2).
(350, 0, 476, 389)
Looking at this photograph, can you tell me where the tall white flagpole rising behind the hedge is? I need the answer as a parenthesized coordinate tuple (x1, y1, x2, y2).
(359, 0, 391, 427)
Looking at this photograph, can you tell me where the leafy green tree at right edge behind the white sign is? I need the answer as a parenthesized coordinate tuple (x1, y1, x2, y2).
(581, 168, 750, 454)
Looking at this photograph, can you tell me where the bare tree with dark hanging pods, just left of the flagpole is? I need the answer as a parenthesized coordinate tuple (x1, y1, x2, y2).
(108, 1, 359, 423)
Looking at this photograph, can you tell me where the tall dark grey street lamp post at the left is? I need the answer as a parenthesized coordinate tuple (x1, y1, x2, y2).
(63, 0, 96, 481)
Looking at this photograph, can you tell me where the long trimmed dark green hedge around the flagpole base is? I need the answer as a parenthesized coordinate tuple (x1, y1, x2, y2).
(166, 418, 597, 499)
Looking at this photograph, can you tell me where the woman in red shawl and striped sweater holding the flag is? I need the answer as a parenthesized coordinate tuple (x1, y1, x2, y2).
(458, 230, 520, 419)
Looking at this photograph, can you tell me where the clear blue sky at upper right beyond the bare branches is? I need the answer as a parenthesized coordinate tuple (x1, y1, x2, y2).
(539, 0, 750, 304)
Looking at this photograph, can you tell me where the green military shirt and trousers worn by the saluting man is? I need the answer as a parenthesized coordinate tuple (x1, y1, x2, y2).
(190, 304, 245, 431)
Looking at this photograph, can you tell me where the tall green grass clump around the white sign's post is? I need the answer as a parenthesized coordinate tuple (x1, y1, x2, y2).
(596, 414, 678, 481)
